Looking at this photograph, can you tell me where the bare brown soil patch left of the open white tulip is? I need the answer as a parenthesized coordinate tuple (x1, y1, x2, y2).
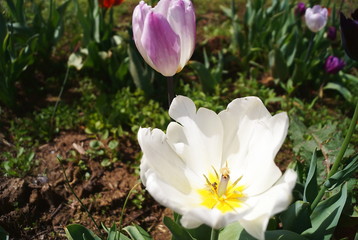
(0, 132, 171, 240)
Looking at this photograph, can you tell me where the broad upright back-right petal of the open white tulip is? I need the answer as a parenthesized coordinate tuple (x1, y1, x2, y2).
(219, 97, 288, 195)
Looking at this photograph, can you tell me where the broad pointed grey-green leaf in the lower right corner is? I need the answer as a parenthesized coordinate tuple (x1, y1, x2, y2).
(302, 183, 347, 240)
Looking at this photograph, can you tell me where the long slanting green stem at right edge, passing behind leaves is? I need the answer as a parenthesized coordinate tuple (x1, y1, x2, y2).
(311, 102, 358, 211)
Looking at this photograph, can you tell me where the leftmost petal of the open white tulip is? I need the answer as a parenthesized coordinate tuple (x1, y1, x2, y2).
(138, 128, 191, 194)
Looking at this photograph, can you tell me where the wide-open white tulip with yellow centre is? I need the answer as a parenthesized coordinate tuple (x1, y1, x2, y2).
(138, 96, 297, 239)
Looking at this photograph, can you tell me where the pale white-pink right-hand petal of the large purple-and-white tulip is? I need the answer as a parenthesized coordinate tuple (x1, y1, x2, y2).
(168, 0, 196, 71)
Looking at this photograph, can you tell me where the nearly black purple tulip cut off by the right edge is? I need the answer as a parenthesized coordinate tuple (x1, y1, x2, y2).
(340, 8, 358, 61)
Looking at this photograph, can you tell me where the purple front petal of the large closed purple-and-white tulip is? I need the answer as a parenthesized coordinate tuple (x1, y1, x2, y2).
(141, 12, 180, 76)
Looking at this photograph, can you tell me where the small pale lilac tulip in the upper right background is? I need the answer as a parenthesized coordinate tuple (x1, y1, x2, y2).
(305, 5, 328, 32)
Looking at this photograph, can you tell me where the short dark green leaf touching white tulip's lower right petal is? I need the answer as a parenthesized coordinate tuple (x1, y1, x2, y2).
(280, 201, 312, 233)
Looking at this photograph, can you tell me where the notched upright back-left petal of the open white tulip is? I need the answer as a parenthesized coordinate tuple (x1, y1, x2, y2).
(167, 96, 223, 177)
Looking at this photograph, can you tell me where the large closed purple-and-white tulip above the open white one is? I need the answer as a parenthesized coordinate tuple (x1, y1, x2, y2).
(132, 0, 196, 76)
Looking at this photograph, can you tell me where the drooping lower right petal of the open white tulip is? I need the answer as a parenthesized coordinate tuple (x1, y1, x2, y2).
(239, 169, 297, 240)
